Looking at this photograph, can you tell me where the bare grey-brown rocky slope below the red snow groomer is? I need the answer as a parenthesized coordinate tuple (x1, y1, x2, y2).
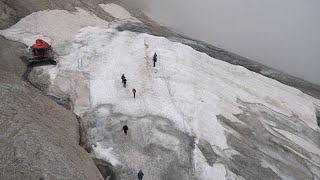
(0, 37, 103, 180)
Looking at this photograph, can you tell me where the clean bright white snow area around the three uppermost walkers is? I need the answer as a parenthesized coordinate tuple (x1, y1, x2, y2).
(63, 27, 317, 177)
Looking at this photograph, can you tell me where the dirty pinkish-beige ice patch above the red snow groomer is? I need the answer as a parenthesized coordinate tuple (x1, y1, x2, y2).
(0, 8, 109, 55)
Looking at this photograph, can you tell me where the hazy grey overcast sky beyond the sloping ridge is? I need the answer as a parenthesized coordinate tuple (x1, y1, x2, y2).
(134, 0, 320, 84)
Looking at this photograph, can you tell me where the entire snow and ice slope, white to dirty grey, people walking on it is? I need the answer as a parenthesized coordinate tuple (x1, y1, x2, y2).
(0, 5, 320, 179)
